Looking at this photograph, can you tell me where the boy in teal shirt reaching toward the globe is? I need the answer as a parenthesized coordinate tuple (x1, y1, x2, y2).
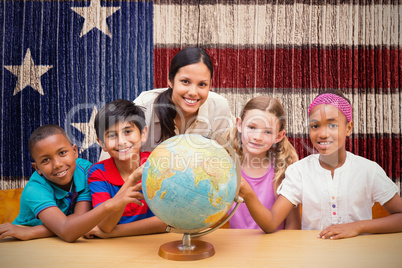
(0, 125, 143, 242)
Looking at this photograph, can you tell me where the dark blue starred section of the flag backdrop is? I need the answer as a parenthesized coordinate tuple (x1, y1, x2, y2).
(0, 0, 153, 189)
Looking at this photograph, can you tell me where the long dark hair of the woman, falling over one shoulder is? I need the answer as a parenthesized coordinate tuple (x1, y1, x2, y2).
(155, 47, 213, 142)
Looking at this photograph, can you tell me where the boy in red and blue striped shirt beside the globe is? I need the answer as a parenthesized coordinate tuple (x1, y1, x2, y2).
(86, 100, 166, 238)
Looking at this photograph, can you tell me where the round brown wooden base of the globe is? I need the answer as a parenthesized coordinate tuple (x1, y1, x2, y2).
(159, 240, 215, 261)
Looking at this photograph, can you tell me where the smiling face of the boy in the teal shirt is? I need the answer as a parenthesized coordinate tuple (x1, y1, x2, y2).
(31, 134, 78, 191)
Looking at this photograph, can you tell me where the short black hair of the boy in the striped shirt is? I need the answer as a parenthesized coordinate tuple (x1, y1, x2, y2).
(94, 99, 146, 142)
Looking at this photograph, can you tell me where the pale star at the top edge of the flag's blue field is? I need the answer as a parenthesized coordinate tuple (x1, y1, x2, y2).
(71, 0, 120, 37)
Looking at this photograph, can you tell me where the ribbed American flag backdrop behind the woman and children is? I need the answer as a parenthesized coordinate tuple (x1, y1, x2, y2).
(0, 0, 402, 193)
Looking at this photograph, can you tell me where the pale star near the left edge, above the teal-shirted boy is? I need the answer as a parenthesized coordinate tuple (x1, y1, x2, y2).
(4, 48, 53, 95)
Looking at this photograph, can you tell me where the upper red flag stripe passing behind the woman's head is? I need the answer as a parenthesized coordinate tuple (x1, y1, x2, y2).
(154, 47, 402, 92)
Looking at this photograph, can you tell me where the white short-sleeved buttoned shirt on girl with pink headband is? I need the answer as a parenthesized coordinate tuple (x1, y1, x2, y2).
(277, 152, 399, 230)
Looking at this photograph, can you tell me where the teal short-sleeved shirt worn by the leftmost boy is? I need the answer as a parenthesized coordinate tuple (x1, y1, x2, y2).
(13, 158, 92, 226)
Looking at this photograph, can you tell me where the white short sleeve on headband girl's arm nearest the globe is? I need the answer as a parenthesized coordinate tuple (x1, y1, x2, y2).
(277, 165, 303, 206)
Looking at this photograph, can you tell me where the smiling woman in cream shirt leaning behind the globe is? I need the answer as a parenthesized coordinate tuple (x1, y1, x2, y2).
(134, 47, 234, 151)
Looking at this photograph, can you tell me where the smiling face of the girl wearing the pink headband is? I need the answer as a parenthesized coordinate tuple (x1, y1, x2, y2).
(309, 104, 353, 155)
